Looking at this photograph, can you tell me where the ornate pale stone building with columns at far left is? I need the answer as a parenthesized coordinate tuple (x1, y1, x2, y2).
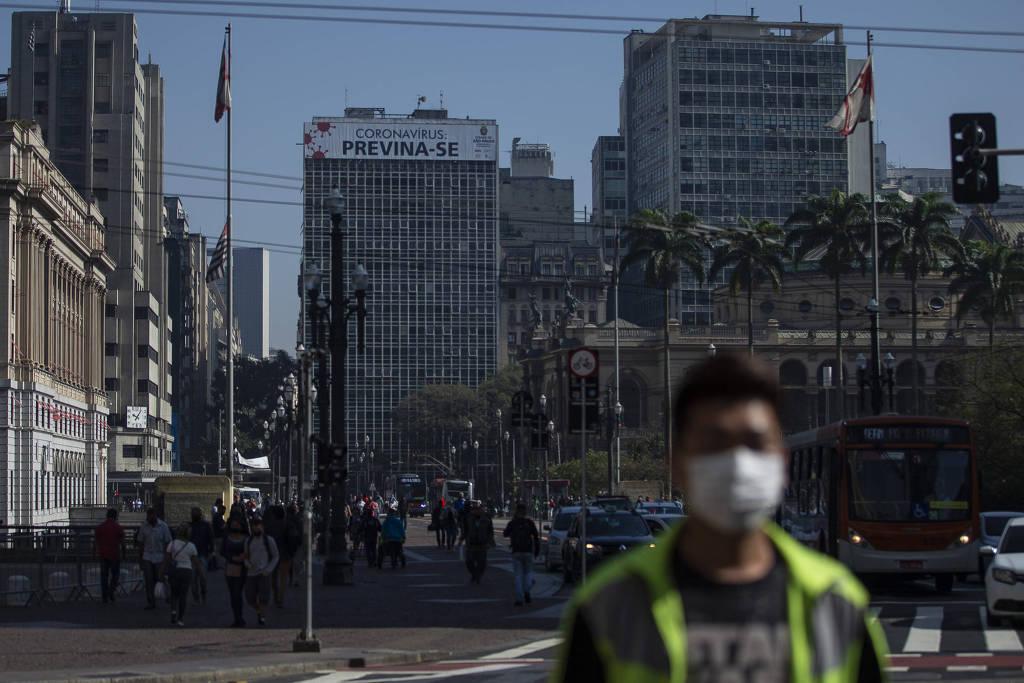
(0, 121, 115, 526)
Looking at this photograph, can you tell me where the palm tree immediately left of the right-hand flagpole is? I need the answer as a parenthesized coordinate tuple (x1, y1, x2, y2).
(785, 189, 869, 420)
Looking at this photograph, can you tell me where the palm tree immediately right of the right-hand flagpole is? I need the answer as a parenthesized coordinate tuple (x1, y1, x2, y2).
(879, 193, 964, 415)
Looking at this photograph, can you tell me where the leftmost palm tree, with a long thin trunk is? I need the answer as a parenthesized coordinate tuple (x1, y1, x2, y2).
(620, 209, 708, 496)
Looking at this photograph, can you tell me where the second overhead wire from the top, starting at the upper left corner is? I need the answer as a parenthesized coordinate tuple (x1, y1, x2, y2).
(0, 0, 1024, 54)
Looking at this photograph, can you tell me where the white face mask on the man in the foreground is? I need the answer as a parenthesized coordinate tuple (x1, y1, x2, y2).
(685, 445, 785, 532)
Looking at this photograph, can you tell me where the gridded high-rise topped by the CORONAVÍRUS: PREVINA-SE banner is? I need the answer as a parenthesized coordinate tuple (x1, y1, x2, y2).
(302, 108, 499, 471)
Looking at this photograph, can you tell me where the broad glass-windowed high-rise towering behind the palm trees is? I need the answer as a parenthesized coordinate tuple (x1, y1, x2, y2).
(621, 15, 848, 324)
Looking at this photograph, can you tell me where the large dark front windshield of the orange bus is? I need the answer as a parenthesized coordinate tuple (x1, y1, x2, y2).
(849, 449, 971, 522)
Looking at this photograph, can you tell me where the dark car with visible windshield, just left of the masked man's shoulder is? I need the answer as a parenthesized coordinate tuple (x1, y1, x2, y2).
(562, 508, 654, 582)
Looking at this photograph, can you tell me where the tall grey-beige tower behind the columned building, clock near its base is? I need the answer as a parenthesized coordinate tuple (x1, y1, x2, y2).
(8, 10, 173, 481)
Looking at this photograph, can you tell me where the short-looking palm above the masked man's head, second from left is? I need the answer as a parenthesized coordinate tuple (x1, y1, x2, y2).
(708, 216, 785, 355)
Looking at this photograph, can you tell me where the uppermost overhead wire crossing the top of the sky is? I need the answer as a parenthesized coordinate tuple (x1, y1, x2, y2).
(59, 0, 1024, 38)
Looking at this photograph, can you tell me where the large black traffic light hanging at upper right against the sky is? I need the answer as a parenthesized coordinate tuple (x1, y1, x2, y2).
(949, 114, 999, 204)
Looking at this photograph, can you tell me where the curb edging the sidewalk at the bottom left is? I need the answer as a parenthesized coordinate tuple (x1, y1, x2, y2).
(6, 648, 452, 683)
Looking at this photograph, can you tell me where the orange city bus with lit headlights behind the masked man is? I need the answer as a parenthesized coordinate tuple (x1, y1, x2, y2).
(779, 416, 981, 592)
